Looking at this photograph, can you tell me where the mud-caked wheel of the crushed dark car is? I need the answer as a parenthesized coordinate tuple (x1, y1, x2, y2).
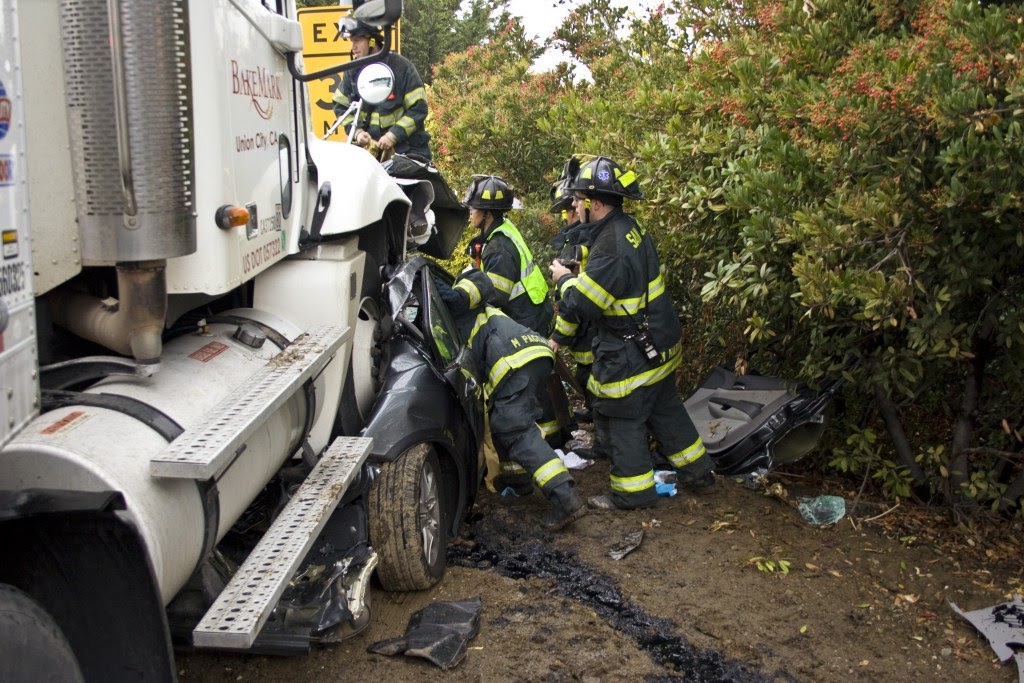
(369, 443, 447, 591)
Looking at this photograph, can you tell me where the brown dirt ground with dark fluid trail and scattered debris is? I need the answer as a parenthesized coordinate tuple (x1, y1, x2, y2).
(177, 428, 1024, 683)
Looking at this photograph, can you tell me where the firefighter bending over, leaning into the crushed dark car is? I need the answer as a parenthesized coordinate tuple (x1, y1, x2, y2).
(436, 269, 587, 531)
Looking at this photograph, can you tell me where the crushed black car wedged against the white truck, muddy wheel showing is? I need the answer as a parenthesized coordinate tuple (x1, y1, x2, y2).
(361, 256, 483, 591)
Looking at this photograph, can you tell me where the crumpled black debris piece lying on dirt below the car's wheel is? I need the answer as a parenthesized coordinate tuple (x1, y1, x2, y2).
(367, 597, 483, 671)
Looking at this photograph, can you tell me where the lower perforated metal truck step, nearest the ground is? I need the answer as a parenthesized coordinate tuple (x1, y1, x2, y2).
(193, 436, 373, 649)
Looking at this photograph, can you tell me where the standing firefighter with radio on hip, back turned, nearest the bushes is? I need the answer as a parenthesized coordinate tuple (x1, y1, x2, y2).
(550, 157, 715, 510)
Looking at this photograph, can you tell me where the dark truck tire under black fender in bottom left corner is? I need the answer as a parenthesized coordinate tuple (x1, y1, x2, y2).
(0, 584, 84, 683)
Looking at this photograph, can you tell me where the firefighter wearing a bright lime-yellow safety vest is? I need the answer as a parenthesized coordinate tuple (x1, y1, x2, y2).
(463, 175, 567, 447)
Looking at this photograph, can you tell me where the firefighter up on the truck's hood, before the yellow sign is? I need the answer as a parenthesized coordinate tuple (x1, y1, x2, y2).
(334, 17, 431, 161)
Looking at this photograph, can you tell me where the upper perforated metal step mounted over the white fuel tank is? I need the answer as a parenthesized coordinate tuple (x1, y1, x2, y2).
(150, 325, 351, 480)
